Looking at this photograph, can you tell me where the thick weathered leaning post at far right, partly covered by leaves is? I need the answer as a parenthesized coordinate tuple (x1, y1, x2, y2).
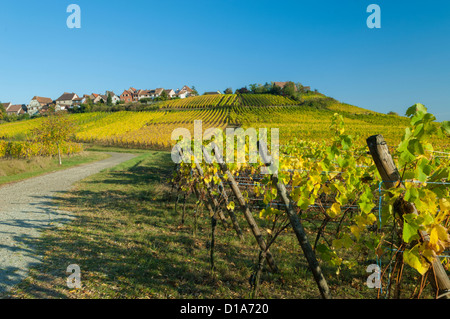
(367, 135, 450, 299)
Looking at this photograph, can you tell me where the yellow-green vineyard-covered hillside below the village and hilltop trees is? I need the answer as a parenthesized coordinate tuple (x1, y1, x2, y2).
(0, 94, 442, 149)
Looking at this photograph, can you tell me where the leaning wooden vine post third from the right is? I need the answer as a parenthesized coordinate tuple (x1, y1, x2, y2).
(211, 143, 278, 272)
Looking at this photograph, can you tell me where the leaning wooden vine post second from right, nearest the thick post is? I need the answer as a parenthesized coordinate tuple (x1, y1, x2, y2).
(258, 141, 331, 299)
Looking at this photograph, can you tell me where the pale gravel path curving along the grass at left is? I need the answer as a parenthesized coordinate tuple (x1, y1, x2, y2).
(0, 153, 134, 293)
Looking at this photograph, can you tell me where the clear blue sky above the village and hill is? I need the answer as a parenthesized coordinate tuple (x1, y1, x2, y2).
(0, 0, 450, 121)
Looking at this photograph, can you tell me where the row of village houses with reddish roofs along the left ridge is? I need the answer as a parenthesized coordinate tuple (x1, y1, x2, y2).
(2, 85, 194, 116)
